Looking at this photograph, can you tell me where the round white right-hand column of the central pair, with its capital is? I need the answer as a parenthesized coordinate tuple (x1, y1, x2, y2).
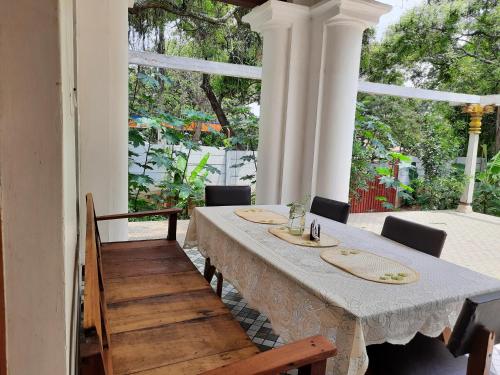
(312, 0, 390, 202)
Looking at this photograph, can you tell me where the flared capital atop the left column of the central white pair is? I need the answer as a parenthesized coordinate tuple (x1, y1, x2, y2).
(243, 0, 310, 33)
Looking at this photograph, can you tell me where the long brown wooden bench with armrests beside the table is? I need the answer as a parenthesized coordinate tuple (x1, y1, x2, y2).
(80, 194, 336, 375)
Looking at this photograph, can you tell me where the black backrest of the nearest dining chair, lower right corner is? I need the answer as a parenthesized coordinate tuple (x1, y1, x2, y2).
(448, 291, 500, 357)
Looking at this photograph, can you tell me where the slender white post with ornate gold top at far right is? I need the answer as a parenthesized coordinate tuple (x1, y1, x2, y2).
(457, 104, 494, 213)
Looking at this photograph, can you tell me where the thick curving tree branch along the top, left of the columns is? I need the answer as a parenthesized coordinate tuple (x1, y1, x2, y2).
(128, 0, 238, 25)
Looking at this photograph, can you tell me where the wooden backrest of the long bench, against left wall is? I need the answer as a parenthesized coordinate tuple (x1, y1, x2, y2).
(80, 193, 113, 375)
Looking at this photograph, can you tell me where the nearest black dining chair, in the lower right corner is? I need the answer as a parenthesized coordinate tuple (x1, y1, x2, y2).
(366, 292, 500, 375)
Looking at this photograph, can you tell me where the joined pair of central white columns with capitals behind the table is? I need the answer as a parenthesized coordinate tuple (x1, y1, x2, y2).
(243, 0, 390, 204)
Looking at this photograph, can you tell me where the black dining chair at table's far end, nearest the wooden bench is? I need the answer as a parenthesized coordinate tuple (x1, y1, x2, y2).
(203, 185, 252, 297)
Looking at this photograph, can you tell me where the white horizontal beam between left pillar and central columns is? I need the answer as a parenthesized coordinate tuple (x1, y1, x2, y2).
(129, 51, 262, 80)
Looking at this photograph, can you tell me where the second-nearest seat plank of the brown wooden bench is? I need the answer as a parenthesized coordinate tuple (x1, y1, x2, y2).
(108, 288, 227, 334)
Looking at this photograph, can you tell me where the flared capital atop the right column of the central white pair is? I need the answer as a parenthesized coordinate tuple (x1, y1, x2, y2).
(311, 0, 392, 30)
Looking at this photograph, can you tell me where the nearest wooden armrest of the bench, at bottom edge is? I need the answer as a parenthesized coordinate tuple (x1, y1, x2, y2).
(202, 336, 337, 375)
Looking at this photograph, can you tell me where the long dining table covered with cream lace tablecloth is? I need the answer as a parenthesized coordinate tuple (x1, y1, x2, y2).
(184, 205, 500, 375)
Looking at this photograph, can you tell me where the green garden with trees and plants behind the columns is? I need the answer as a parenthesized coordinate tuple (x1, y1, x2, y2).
(129, 0, 500, 218)
